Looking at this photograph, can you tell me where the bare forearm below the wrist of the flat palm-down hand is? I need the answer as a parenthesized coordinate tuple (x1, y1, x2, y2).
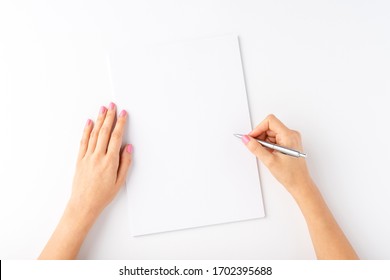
(38, 202, 97, 259)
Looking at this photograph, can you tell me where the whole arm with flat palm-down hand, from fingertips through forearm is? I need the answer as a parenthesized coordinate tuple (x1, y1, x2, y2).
(39, 103, 133, 259)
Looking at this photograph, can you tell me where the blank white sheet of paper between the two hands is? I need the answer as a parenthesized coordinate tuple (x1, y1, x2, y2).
(110, 36, 264, 236)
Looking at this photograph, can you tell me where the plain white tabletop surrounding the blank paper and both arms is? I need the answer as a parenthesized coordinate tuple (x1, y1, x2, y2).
(0, 0, 390, 259)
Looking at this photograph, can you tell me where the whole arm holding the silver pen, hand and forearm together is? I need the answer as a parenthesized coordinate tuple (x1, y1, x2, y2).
(242, 115, 359, 259)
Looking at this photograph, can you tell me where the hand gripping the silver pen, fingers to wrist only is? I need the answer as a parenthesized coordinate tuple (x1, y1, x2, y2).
(242, 115, 311, 195)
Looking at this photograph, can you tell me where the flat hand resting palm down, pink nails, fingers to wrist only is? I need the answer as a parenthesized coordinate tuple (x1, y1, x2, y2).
(70, 103, 133, 219)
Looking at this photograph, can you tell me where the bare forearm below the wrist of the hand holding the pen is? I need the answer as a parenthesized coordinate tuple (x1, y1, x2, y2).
(293, 180, 358, 259)
